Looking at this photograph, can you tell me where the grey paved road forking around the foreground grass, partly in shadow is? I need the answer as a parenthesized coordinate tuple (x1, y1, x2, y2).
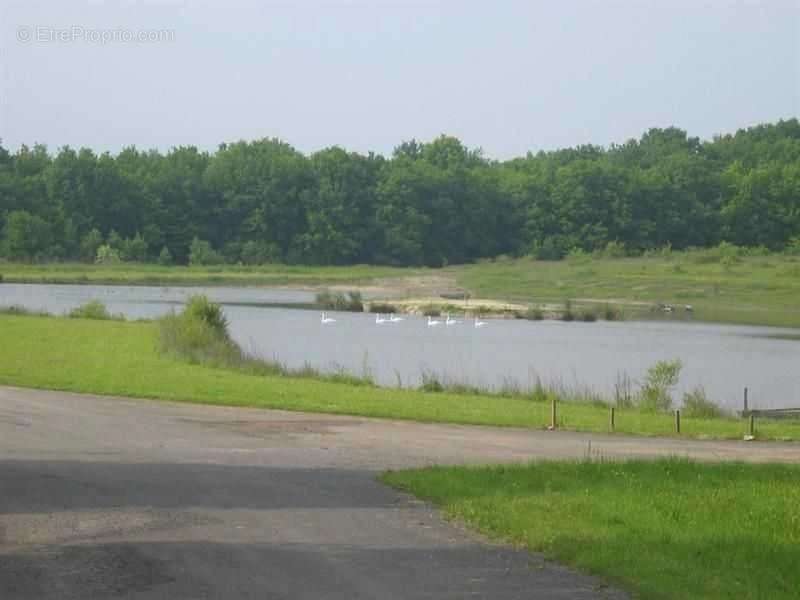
(0, 387, 800, 600)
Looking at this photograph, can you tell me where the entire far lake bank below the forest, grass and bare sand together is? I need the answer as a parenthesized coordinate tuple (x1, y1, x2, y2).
(0, 248, 800, 327)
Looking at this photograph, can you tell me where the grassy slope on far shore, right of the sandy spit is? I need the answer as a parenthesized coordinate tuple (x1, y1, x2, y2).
(454, 251, 800, 327)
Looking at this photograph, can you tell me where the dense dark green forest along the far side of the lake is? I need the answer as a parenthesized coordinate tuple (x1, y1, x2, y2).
(0, 118, 800, 266)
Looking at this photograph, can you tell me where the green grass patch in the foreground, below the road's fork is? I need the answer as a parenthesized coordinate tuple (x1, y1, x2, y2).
(383, 460, 800, 600)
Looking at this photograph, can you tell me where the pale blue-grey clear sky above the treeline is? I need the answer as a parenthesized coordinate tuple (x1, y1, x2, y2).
(0, 0, 800, 160)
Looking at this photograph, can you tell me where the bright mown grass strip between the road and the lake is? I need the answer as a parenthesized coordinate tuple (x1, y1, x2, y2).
(0, 314, 800, 440)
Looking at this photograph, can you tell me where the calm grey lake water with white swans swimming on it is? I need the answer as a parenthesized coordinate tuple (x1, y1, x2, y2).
(0, 284, 800, 408)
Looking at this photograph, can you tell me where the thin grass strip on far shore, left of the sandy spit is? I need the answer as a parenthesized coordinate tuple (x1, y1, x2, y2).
(0, 263, 424, 286)
